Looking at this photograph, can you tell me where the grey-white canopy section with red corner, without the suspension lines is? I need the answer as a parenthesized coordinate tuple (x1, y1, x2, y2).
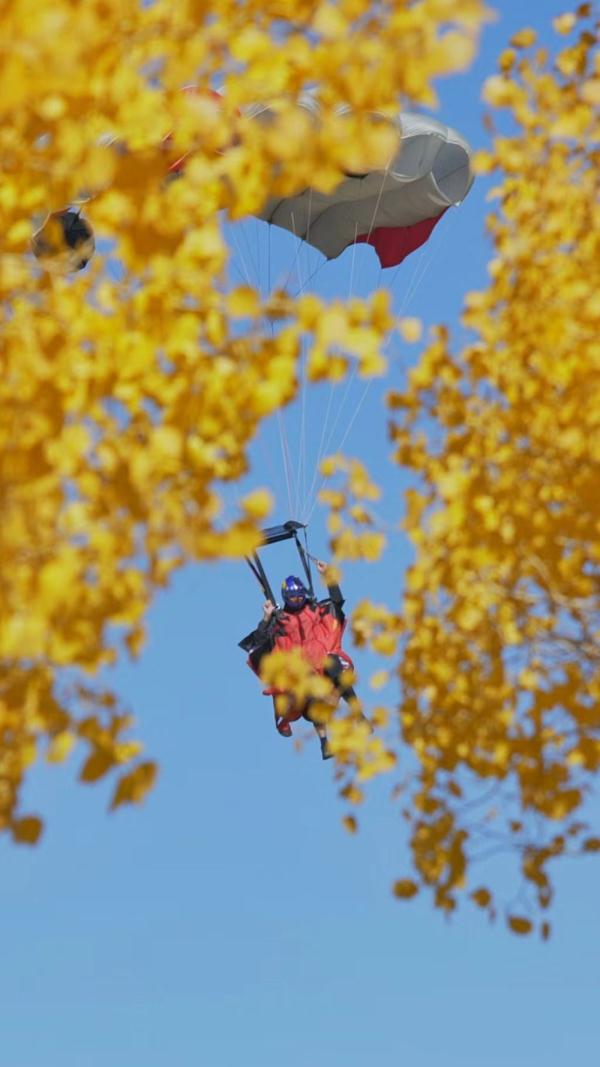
(243, 97, 473, 267)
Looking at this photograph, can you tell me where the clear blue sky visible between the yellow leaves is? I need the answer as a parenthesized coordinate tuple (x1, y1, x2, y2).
(0, 0, 600, 1067)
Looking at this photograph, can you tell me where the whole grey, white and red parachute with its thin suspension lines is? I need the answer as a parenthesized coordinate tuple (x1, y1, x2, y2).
(32, 94, 473, 559)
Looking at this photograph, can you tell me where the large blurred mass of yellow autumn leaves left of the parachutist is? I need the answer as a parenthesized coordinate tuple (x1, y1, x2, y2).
(0, 0, 483, 842)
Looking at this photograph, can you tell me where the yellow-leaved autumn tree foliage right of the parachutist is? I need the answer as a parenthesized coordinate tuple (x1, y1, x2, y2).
(328, 4, 600, 936)
